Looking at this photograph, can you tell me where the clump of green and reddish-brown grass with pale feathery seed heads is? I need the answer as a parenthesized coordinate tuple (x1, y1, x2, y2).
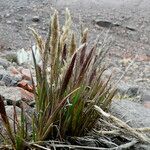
(0, 9, 116, 148)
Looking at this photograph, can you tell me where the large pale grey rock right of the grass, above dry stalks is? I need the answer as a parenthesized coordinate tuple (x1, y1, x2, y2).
(110, 99, 150, 128)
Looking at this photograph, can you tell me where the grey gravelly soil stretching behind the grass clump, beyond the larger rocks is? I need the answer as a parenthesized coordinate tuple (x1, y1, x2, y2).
(0, 0, 150, 90)
